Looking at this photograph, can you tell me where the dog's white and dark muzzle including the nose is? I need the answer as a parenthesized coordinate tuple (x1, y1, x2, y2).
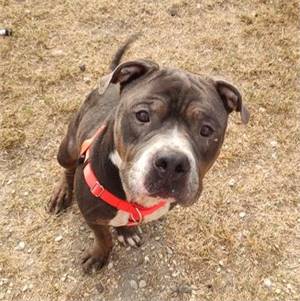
(126, 129, 199, 204)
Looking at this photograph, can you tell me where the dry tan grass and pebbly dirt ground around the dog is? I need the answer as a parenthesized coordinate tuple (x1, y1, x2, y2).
(0, 0, 300, 301)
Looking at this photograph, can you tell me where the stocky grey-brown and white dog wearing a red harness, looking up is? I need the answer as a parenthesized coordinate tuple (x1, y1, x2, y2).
(49, 38, 249, 272)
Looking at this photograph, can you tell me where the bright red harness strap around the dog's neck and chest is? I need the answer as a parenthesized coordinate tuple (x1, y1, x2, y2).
(80, 124, 166, 226)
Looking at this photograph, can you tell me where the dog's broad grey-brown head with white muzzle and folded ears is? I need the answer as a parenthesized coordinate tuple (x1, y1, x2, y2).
(100, 60, 249, 206)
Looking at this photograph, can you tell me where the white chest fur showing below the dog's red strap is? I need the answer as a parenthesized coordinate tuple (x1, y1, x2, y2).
(109, 202, 170, 227)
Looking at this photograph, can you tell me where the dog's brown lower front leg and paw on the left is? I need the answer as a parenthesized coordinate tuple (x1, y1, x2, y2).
(82, 224, 112, 273)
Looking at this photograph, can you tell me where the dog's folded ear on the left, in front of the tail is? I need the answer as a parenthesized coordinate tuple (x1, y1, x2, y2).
(99, 60, 159, 95)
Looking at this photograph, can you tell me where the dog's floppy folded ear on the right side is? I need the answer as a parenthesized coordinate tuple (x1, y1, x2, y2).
(215, 79, 250, 124)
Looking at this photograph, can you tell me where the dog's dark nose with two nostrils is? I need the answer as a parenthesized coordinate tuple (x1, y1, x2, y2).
(153, 152, 191, 180)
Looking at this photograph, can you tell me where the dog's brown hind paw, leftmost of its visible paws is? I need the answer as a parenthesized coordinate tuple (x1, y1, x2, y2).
(47, 181, 72, 214)
